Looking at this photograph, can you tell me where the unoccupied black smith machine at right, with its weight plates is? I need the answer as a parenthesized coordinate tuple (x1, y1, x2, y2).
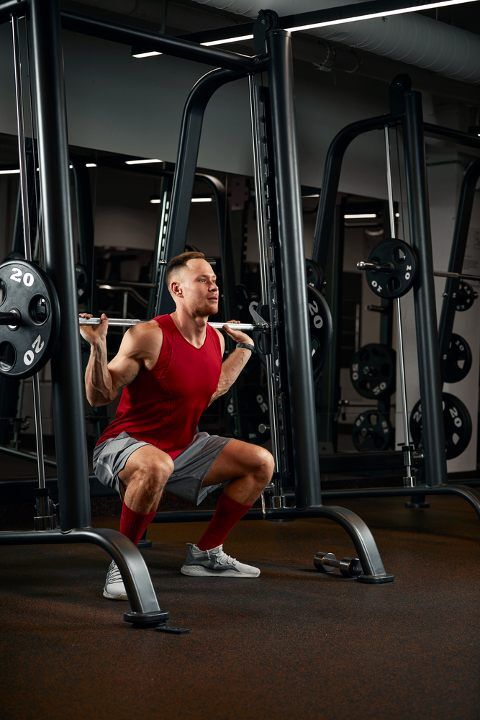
(313, 76, 480, 515)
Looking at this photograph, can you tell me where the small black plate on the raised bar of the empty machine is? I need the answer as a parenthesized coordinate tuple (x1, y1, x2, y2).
(366, 240, 417, 298)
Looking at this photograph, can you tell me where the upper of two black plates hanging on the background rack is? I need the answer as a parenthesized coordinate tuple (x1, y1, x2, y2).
(350, 343, 395, 398)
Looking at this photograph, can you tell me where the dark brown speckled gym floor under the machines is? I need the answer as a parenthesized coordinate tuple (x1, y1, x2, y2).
(0, 496, 480, 720)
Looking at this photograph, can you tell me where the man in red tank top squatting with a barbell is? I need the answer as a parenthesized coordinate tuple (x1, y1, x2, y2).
(80, 252, 274, 600)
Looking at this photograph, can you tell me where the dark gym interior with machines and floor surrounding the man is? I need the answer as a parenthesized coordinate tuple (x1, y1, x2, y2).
(0, 0, 480, 720)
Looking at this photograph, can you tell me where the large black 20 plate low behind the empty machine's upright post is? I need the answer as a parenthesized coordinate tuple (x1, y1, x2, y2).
(410, 393, 472, 460)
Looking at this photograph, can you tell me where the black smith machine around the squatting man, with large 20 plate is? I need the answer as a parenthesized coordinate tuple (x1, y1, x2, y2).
(0, 0, 393, 631)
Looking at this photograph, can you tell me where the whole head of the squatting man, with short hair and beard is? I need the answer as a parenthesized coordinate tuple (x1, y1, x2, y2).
(165, 252, 219, 317)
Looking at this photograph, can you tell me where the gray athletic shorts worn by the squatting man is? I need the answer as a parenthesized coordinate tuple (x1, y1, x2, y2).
(93, 432, 230, 505)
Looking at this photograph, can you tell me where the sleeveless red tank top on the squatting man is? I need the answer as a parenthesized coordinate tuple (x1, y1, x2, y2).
(97, 315, 222, 459)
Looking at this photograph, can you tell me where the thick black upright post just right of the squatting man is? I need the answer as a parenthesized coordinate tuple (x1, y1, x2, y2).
(267, 30, 321, 508)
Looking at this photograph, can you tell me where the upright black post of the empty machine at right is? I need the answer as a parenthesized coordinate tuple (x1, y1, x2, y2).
(404, 90, 447, 485)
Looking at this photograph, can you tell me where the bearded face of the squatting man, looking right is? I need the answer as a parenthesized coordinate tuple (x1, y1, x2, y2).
(170, 258, 219, 317)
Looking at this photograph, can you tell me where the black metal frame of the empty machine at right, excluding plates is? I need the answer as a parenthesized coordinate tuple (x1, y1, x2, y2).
(312, 77, 480, 515)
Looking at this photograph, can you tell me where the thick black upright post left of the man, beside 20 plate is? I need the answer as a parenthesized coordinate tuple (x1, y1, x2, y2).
(30, 0, 90, 530)
